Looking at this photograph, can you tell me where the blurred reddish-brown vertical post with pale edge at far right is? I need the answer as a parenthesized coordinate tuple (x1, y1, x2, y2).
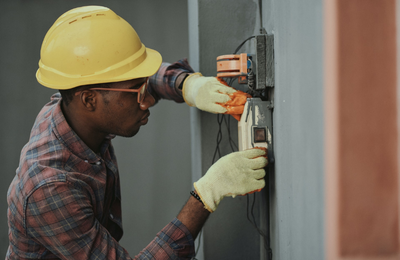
(324, 0, 400, 260)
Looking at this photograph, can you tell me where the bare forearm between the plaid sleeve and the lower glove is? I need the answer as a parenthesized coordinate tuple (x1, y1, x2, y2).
(177, 191, 210, 239)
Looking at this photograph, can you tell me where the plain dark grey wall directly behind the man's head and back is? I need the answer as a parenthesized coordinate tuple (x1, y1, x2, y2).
(0, 0, 191, 256)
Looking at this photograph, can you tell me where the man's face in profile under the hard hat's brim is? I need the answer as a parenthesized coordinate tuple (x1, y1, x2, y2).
(99, 78, 155, 137)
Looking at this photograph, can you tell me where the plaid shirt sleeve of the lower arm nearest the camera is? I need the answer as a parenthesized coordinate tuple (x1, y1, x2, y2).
(25, 181, 194, 259)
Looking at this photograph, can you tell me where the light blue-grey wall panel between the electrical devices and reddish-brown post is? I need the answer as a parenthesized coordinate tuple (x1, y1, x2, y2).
(264, 0, 324, 260)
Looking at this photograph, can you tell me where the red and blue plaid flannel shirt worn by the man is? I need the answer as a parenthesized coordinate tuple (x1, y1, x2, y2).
(6, 60, 194, 259)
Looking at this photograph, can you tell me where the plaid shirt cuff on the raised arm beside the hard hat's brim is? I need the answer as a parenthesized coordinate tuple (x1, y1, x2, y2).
(148, 59, 194, 103)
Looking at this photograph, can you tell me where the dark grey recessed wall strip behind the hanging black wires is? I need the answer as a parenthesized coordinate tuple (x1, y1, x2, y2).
(198, 0, 266, 259)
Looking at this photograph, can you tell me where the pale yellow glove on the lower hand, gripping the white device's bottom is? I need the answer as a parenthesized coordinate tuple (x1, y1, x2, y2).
(194, 148, 268, 212)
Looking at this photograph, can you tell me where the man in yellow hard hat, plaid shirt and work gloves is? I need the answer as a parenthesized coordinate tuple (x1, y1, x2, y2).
(6, 6, 267, 259)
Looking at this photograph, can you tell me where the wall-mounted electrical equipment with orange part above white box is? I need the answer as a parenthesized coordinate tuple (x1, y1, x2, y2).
(217, 34, 275, 157)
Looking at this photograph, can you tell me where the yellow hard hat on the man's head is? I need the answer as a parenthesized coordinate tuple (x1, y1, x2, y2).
(36, 6, 162, 89)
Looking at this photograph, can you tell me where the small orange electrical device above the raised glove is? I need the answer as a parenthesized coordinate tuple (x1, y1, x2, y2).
(217, 53, 248, 84)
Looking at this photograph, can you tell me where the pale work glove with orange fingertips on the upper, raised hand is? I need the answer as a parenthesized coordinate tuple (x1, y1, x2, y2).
(182, 73, 251, 121)
